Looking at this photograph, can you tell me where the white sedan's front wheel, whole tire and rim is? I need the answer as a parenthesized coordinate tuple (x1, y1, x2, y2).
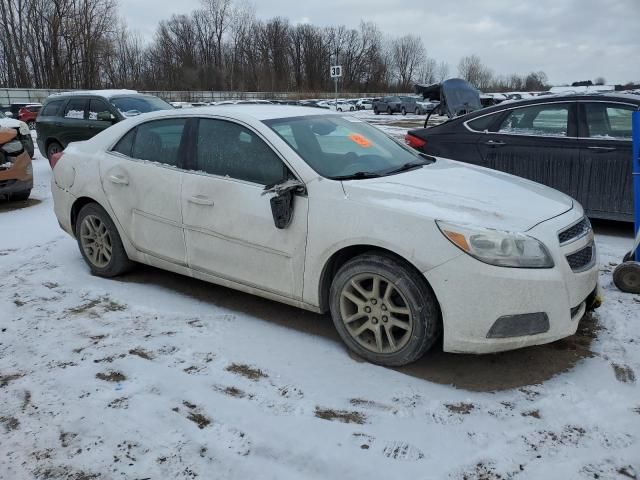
(329, 252, 441, 367)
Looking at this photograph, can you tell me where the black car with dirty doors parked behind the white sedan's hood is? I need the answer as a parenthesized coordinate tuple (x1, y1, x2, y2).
(405, 94, 640, 221)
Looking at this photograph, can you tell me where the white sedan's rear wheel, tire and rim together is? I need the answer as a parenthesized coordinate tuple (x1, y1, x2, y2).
(75, 203, 133, 278)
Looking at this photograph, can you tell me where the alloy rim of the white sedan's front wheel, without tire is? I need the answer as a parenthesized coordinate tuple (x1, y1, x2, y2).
(340, 273, 414, 354)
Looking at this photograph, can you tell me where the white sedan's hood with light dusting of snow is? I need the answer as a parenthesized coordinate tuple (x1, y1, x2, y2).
(343, 159, 573, 231)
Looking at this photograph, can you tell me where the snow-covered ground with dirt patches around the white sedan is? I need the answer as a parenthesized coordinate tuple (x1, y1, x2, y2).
(0, 124, 640, 480)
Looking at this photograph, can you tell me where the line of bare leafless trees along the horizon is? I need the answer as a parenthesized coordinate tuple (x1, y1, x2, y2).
(0, 0, 604, 92)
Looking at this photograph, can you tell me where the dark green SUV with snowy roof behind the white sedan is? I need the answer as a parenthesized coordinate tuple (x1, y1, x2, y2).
(36, 90, 173, 161)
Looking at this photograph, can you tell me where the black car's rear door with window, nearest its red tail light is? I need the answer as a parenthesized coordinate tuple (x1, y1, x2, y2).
(477, 102, 584, 200)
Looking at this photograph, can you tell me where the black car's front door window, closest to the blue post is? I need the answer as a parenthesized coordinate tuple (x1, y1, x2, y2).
(585, 102, 634, 140)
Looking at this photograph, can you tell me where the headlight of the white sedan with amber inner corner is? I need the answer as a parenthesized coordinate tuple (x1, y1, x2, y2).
(436, 221, 554, 268)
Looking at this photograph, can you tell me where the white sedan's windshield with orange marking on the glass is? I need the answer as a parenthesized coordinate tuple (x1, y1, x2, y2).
(264, 115, 428, 178)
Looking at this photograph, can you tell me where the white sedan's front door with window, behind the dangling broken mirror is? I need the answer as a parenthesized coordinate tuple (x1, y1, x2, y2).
(182, 118, 308, 298)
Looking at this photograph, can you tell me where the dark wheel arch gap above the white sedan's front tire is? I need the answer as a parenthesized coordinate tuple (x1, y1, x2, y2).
(318, 244, 442, 321)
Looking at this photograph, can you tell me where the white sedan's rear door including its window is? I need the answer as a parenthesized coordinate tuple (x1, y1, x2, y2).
(100, 118, 187, 265)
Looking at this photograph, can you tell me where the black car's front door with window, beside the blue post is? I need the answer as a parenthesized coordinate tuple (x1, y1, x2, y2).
(579, 100, 638, 221)
